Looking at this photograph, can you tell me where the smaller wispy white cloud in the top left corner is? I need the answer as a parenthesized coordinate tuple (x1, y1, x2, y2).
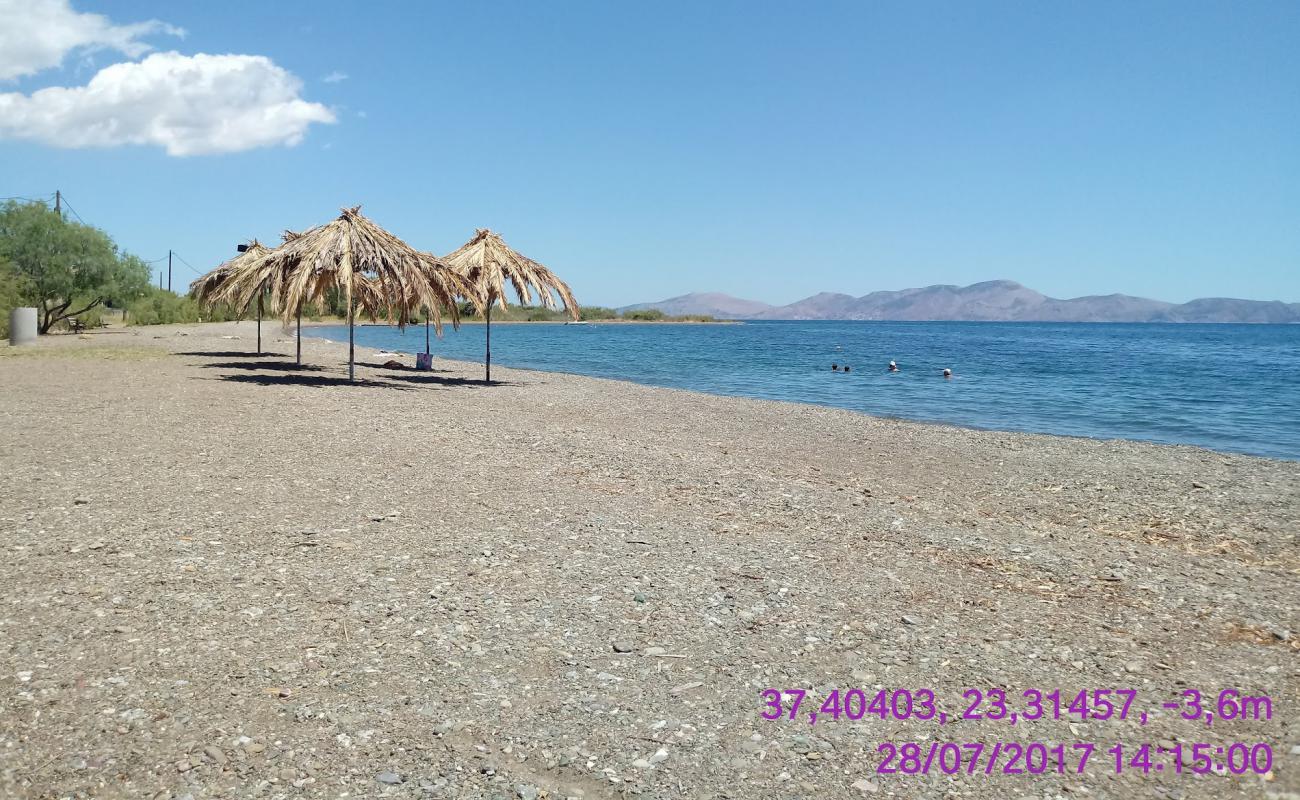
(0, 0, 185, 81)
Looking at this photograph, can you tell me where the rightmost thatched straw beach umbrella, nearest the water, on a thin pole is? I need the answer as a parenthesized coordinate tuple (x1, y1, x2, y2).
(443, 228, 579, 384)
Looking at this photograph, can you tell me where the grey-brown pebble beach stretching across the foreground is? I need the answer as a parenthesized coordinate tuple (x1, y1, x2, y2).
(0, 320, 1300, 799)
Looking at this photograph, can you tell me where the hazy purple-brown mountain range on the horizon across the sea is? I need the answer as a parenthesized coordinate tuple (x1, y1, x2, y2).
(627, 281, 1300, 323)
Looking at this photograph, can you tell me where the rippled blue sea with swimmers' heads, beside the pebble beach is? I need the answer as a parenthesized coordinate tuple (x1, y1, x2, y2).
(313, 321, 1300, 459)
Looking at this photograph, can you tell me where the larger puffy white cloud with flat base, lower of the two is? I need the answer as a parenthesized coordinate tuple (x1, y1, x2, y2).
(0, 51, 334, 156)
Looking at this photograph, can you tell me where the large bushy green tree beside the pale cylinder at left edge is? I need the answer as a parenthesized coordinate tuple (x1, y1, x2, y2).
(0, 200, 150, 333)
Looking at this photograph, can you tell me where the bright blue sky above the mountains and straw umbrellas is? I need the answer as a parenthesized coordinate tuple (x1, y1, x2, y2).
(0, 0, 1300, 304)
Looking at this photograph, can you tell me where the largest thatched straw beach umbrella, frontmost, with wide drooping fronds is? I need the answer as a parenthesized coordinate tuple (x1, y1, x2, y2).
(220, 206, 459, 380)
